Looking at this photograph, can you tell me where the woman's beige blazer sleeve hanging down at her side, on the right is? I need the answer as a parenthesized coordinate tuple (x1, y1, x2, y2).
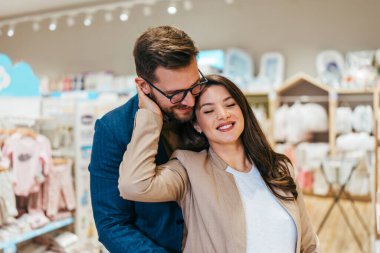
(288, 164, 321, 253)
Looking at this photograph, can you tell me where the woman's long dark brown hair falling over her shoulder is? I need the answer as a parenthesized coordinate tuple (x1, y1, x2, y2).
(180, 75, 298, 200)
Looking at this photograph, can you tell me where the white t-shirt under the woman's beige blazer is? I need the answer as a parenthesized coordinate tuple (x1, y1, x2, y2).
(227, 166, 297, 253)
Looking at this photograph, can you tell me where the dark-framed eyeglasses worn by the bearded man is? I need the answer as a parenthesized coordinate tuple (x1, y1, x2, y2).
(143, 69, 208, 104)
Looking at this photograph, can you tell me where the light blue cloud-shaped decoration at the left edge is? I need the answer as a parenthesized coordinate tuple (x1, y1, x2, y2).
(0, 53, 40, 97)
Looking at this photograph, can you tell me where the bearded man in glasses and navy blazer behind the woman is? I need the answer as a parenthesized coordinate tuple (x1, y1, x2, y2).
(89, 26, 205, 253)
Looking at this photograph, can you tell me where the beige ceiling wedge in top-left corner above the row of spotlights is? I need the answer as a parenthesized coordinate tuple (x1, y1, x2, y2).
(0, 0, 110, 20)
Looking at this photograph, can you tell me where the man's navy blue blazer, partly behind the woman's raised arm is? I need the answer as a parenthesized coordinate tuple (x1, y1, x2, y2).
(89, 96, 183, 253)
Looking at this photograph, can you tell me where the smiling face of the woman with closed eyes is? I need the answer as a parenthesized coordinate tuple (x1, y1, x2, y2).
(194, 85, 244, 146)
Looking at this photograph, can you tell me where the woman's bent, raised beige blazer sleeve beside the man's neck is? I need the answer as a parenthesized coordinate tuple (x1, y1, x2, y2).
(119, 109, 188, 202)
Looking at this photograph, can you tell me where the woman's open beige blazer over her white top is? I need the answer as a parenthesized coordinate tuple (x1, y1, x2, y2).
(119, 109, 319, 253)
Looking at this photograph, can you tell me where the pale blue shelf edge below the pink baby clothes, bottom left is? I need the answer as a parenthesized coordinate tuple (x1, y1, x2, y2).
(0, 217, 74, 252)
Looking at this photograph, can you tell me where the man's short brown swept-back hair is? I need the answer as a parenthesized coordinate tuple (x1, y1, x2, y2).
(133, 26, 198, 82)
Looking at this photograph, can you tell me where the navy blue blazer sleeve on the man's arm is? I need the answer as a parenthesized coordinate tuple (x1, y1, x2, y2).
(89, 120, 167, 253)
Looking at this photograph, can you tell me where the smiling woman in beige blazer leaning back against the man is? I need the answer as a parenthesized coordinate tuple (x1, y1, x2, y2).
(119, 75, 319, 253)
